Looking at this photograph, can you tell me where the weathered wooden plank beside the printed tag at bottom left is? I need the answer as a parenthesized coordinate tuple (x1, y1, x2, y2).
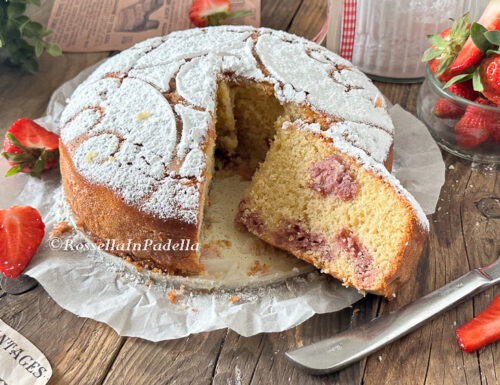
(0, 286, 123, 385)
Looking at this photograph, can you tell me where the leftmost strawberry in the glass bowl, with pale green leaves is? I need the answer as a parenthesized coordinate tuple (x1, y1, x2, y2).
(422, 13, 470, 82)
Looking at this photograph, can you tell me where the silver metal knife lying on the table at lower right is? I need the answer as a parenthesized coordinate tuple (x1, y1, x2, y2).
(285, 257, 500, 374)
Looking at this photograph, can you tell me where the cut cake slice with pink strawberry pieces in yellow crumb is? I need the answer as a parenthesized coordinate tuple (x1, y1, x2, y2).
(237, 121, 428, 297)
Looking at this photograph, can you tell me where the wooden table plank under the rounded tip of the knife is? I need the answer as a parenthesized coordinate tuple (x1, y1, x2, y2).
(213, 296, 378, 385)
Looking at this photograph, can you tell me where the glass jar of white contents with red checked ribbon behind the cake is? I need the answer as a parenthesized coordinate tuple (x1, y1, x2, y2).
(327, 0, 488, 83)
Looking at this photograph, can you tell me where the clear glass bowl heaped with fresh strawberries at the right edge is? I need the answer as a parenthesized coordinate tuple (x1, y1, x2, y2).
(417, 4, 500, 163)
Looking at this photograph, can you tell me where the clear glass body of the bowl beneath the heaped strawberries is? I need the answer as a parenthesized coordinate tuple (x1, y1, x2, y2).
(417, 66, 500, 163)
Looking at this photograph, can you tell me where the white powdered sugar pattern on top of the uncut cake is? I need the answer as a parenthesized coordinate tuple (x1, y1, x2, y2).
(61, 26, 394, 224)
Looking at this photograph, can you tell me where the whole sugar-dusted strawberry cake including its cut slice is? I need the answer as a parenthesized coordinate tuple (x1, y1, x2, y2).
(60, 26, 429, 297)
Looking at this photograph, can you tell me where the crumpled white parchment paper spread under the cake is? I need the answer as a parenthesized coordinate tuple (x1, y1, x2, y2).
(0, 66, 445, 341)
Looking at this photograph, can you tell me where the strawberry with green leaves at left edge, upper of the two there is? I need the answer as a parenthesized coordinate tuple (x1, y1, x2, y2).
(2, 118, 59, 177)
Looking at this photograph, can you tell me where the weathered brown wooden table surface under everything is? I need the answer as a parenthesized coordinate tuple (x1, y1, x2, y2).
(0, 0, 500, 385)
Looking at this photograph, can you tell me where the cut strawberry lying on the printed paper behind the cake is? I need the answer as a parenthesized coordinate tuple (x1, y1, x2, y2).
(189, 0, 252, 27)
